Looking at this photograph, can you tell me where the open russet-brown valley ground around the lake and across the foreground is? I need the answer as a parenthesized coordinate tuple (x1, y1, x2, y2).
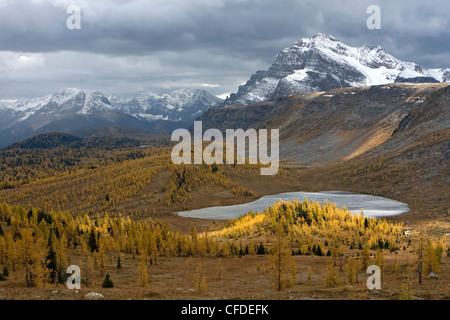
(0, 137, 450, 300)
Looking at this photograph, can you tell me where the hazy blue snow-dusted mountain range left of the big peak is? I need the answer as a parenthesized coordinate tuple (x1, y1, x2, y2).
(0, 89, 223, 146)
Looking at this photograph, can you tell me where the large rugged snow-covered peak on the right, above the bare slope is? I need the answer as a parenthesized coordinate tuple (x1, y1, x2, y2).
(225, 34, 450, 105)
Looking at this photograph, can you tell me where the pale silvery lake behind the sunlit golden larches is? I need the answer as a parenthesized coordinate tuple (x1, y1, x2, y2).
(178, 191, 410, 220)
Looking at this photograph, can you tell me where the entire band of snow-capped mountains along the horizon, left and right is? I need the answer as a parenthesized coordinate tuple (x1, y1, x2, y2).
(0, 34, 450, 147)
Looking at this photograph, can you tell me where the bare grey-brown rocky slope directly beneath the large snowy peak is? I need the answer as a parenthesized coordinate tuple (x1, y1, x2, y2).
(200, 84, 448, 166)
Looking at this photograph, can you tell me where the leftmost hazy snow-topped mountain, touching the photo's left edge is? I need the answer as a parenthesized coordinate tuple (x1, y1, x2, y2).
(0, 89, 156, 146)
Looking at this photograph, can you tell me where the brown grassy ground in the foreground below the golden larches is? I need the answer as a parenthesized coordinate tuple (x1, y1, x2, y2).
(0, 250, 450, 300)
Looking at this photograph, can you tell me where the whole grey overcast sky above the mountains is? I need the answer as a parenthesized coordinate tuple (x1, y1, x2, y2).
(0, 0, 450, 100)
